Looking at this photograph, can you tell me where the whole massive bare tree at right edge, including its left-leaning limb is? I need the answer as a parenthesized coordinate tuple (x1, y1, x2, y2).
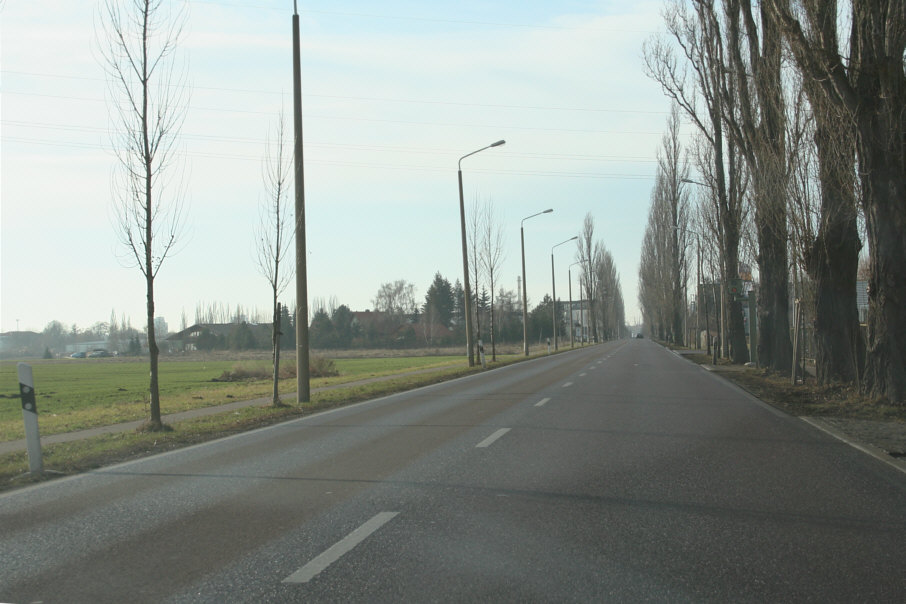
(766, 0, 906, 405)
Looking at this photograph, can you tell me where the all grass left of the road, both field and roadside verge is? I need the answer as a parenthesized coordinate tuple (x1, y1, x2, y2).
(0, 354, 552, 490)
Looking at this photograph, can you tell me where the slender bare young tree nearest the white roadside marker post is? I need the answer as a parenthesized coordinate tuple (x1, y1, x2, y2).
(98, 0, 187, 430)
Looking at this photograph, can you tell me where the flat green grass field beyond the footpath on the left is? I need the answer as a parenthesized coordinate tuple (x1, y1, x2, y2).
(0, 356, 466, 441)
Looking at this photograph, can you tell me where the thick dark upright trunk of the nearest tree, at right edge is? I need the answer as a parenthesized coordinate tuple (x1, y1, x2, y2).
(850, 0, 906, 405)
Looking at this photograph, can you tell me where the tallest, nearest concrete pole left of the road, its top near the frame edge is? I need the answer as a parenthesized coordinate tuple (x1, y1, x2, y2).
(293, 0, 311, 403)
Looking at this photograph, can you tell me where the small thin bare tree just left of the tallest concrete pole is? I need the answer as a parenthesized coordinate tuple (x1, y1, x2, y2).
(255, 111, 294, 406)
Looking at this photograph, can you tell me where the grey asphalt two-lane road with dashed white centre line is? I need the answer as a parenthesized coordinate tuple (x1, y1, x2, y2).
(0, 340, 906, 602)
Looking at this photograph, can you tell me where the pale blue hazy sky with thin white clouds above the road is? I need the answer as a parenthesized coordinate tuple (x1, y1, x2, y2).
(0, 0, 669, 332)
